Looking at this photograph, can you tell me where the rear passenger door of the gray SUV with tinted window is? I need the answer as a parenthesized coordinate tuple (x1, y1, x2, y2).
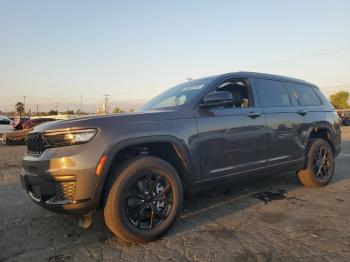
(254, 78, 307, 166)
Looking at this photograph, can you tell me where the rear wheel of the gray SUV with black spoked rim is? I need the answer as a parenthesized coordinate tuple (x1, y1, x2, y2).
(298, 138, 334, 187)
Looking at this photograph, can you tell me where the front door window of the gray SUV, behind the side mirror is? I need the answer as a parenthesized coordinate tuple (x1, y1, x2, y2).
(214, 79, 253, 108)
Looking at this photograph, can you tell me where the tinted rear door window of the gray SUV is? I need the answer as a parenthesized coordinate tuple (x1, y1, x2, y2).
(254, 79, 292, 107)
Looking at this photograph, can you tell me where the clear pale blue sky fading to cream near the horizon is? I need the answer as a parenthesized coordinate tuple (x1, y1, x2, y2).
(0, 0, 350, 111)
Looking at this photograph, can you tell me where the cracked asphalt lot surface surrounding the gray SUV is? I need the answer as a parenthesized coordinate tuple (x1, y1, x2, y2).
(0, 128, 350, 262)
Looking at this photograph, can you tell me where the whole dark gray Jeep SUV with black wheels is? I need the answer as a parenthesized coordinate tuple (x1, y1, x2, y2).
(20, 72, 341, 243)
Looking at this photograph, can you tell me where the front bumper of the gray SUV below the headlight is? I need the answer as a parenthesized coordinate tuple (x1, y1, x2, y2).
(20, 141, 105, 214)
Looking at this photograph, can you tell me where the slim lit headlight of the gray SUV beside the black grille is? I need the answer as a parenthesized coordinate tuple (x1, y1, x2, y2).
(44, 129, 97, 146)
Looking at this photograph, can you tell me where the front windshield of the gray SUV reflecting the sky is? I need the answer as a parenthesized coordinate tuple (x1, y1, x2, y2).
(142, 77, 214, 109)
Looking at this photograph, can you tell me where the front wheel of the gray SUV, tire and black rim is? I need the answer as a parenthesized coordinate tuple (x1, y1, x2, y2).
(104, 156, 183, 244)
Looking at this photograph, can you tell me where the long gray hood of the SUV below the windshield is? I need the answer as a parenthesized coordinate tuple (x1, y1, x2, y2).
(33, 110, 193, 132)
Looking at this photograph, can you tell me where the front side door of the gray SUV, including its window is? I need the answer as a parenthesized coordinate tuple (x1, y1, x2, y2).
(196, 78, 266, 180)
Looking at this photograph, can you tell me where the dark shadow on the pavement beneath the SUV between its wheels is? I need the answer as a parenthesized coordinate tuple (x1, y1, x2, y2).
(167, 173, 304, 236)
